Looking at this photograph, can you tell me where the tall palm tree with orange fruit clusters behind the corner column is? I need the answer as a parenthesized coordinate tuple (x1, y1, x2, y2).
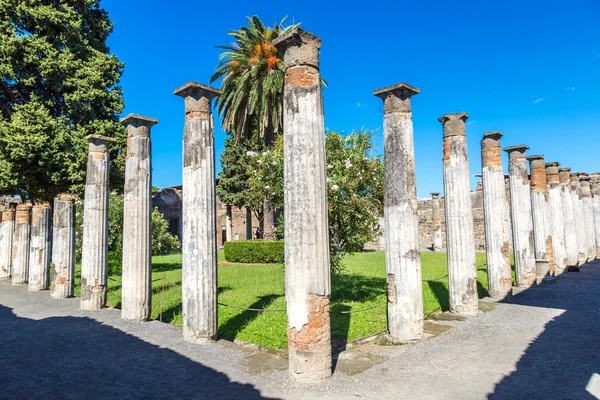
(210, 16, 300, 240)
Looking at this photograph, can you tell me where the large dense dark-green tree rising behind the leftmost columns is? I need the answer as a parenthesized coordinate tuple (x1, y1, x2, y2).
(0, 0, 126, 200)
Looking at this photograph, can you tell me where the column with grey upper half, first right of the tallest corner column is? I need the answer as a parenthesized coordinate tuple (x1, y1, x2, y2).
(373, 83, 422, 343)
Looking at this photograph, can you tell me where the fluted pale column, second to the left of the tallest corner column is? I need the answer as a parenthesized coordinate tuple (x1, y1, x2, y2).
(121, 114, 158, 321)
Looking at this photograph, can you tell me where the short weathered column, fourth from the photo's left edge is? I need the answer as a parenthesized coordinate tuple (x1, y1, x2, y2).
(50, 194, 75, 299)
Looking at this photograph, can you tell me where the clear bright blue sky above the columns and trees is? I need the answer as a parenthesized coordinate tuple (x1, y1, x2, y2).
(102, 0, 600, 197)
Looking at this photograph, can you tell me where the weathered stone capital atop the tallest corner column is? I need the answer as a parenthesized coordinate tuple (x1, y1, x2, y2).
(273, 28, 321, 69)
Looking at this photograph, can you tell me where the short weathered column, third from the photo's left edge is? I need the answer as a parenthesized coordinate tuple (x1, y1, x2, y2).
(27, 202, 52, 292)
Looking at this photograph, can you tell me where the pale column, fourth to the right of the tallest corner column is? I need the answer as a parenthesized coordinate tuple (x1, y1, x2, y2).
(504, 145, 536, 287)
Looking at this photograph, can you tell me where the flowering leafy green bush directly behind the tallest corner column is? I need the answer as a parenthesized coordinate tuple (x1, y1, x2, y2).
(248, 131, 383, 273)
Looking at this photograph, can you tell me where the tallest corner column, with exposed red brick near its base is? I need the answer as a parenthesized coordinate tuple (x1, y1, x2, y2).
(273, 28, 332, 382)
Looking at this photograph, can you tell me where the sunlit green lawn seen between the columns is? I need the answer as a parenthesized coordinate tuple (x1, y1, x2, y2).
(75, 251, 512, 348)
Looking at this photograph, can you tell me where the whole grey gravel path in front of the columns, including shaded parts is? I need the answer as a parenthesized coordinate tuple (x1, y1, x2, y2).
(0, 262, 600, 400)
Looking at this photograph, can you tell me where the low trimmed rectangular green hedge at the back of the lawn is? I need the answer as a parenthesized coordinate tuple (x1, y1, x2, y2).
(223, 240, 284, 264)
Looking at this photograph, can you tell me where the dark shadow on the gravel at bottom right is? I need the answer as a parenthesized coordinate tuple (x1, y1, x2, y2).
(489, 261, 600, 400)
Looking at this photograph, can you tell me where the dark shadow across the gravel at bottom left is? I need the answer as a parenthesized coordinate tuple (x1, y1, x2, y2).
(0, 306, 272, 399)
